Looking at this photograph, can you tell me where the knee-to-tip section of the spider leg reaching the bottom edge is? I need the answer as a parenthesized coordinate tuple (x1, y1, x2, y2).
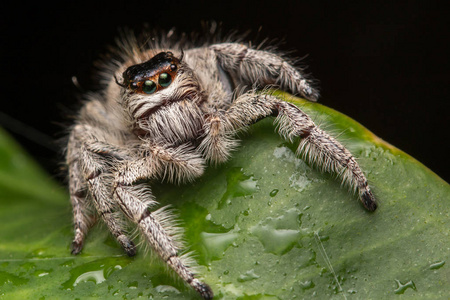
(114, 151, 213, 299)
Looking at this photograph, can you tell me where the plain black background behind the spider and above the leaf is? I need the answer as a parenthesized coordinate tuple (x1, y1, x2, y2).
(0, 1, 450, 181)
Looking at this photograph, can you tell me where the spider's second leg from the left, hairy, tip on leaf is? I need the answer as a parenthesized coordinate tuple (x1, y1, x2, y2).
(69, 125, 136, 256)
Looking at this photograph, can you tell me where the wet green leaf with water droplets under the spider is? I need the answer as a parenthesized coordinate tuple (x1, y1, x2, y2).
(0, 94, 450, 299)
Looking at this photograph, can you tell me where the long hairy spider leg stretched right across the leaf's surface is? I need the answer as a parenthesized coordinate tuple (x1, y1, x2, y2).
(200, 92, 377, 211)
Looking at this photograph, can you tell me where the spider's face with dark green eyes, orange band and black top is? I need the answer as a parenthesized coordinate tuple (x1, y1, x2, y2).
(118, 52, 204, 120)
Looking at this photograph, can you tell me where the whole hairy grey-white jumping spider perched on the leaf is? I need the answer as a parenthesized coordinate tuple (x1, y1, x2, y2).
(66, 29, 377, 299)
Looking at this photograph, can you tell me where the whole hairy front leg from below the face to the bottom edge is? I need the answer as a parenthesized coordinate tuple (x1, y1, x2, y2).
(113, 146, 213, 299)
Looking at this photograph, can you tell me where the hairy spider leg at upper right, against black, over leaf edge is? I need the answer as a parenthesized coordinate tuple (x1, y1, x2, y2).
(210, 43, 319, 101)
